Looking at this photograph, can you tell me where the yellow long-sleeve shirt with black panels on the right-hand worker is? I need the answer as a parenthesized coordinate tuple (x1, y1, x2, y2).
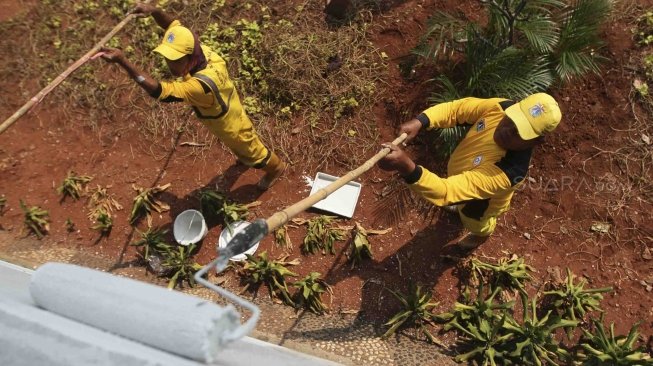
(406, 98, 531, 219)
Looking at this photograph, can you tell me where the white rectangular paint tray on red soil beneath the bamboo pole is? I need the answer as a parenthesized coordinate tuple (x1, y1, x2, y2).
(311, 172, 361, 218)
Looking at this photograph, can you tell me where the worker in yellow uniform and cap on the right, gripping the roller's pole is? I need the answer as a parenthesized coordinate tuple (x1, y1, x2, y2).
(379, 93, 562, 248)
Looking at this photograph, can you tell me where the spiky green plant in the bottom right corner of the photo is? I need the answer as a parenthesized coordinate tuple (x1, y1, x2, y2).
(579, 319, 653, 366)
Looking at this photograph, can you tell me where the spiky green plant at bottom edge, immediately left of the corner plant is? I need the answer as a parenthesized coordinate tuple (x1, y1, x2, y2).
(503, 299, 578, 365)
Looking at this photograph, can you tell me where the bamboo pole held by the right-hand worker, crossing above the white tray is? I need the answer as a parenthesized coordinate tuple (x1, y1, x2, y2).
(265, 133, 407, 233)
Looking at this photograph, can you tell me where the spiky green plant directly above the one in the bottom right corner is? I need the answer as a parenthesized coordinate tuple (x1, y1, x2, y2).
(544, 268, 612, 335)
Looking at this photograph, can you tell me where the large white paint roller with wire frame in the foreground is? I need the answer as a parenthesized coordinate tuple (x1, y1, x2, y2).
(29, 263, 260, 363)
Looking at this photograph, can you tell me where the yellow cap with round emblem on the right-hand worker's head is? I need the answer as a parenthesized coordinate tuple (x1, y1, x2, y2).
(506, 93, 562, 140)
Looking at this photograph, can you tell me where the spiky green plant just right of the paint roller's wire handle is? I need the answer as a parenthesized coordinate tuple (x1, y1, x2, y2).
(240, 252, 299, 305)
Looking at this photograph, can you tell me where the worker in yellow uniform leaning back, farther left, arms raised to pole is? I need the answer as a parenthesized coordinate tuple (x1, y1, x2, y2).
(102, 4, 286, 190)
